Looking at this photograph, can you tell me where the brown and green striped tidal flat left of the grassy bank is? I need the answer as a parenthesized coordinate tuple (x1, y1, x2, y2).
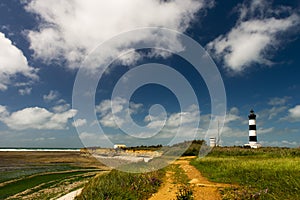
(0, 152, 106, 199)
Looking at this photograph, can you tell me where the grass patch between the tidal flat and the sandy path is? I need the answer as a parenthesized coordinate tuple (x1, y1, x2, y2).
(76, 170, 164, 200)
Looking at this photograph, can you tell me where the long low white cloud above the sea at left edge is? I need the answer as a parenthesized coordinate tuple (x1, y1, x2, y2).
(0, 106, 77, 130)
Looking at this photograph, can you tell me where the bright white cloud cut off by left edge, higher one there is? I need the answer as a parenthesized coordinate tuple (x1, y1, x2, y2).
(0, 32, 38, 91)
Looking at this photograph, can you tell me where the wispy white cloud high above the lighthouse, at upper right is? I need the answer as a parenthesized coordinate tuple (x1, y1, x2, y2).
(206, 0, 300, 72)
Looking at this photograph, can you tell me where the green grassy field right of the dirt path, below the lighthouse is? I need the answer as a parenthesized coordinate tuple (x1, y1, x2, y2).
(192, 147, 300, 200)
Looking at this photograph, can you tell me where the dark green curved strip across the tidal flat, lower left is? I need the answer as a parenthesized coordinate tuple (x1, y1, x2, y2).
(0, 171, 94, 199)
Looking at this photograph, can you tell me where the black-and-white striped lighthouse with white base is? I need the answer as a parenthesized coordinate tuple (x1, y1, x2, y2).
(244, 109, 261, 148)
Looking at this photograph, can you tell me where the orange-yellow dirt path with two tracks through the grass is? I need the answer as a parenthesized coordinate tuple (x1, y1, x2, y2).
(150, 157, 231, 200)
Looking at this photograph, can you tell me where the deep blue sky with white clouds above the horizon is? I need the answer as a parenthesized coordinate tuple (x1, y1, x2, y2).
(0, 0, 300, 147)
